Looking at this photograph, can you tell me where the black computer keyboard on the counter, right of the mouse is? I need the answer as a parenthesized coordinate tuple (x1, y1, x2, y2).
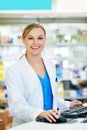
(61, 106, 87, 118)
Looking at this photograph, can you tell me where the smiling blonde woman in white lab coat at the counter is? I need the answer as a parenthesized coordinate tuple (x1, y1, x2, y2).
(5, 23, 82, 125)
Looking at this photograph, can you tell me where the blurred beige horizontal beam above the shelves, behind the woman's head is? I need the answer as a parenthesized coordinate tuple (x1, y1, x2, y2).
(0, 13, 87, 24)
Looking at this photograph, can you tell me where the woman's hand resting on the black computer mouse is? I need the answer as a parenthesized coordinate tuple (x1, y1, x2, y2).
(37, 110, 60, 122)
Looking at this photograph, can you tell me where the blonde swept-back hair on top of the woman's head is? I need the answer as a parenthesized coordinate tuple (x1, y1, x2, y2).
(22, 23, 46, 39)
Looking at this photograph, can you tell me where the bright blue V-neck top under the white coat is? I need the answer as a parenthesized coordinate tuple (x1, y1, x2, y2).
(38, 71, 53, 110)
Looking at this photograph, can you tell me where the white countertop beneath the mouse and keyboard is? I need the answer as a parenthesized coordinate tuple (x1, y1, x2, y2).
(9, 118, 87, 130)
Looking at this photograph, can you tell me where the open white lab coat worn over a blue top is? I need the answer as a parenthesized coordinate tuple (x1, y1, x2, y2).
(5, 56, 70, 125)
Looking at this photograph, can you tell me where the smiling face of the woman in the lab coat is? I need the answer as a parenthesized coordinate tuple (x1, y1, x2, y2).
(22, 23, 46, 56)
